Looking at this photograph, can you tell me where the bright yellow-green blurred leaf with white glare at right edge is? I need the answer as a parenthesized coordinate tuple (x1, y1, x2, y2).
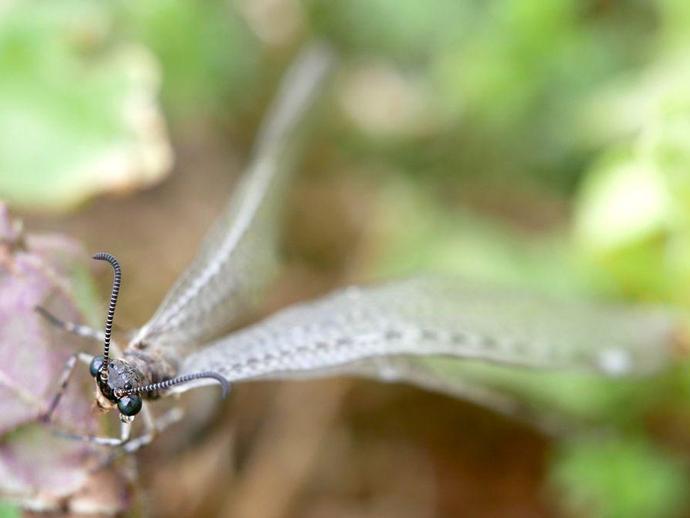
(575, 47, 690, 307)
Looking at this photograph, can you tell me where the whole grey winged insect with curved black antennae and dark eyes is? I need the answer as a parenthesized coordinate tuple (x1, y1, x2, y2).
(39, 43, 675, 451)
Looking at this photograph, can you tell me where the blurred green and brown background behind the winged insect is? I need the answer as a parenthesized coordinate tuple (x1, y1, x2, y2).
(0, 0, 690, 518)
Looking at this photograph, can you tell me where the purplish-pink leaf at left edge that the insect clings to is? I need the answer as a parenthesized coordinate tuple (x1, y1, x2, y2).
(0, 206, 127, 512)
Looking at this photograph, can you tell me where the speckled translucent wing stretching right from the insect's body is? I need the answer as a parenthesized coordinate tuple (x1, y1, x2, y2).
(183, 278, 675, 392)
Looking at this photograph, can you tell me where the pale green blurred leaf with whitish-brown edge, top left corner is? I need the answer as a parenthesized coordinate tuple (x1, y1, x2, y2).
(0, 0, 171, 210)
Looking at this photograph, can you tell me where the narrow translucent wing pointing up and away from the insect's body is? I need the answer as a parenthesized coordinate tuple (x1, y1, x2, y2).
(133, 45, 333, 354)
